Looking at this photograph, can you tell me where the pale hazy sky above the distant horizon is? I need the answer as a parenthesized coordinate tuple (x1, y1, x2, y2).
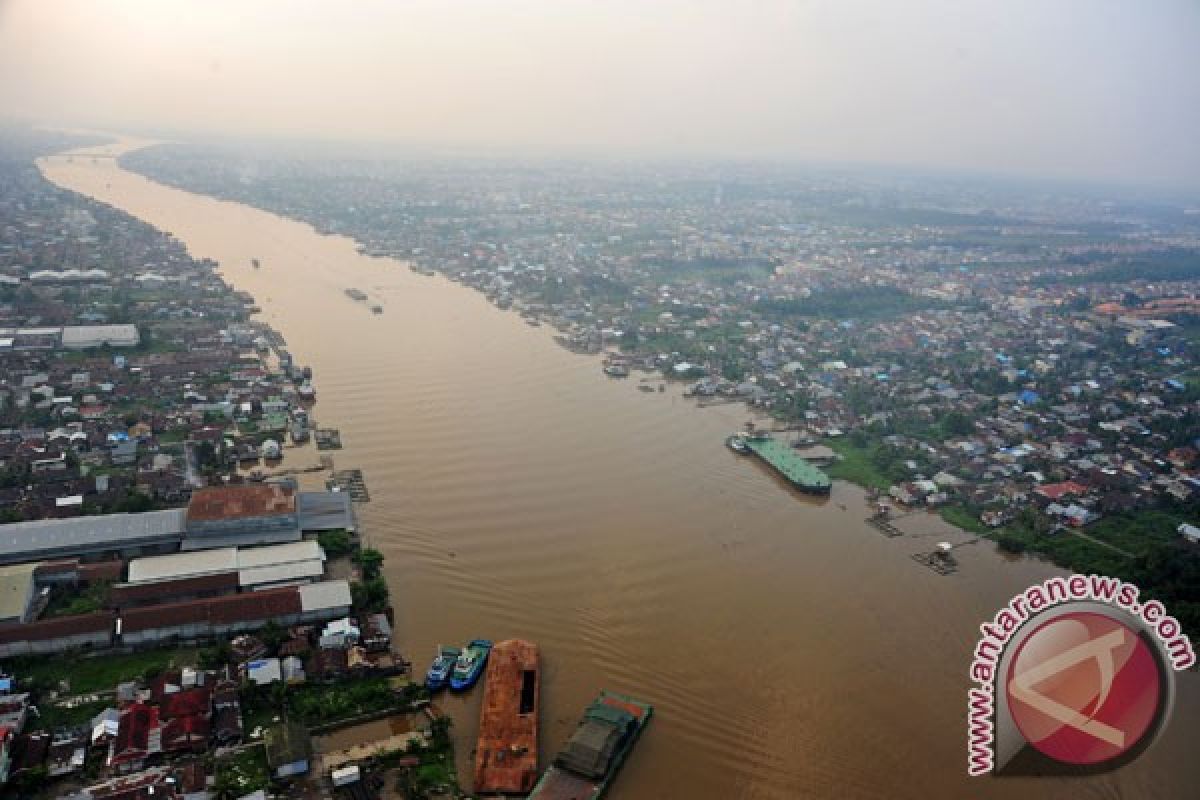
(0, 0, 1200, 187)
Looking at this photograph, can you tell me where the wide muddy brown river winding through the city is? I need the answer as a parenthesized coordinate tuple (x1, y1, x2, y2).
(40, 140, 1200, 800)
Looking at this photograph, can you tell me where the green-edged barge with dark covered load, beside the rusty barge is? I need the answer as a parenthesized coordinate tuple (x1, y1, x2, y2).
(528, 691, 654, 800)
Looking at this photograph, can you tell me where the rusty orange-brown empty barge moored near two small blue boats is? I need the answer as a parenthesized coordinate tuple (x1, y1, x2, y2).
(475, 639, 540, 796)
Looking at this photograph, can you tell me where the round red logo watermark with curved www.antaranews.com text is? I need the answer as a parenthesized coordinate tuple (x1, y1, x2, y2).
(967, 575, 1195, 775)
